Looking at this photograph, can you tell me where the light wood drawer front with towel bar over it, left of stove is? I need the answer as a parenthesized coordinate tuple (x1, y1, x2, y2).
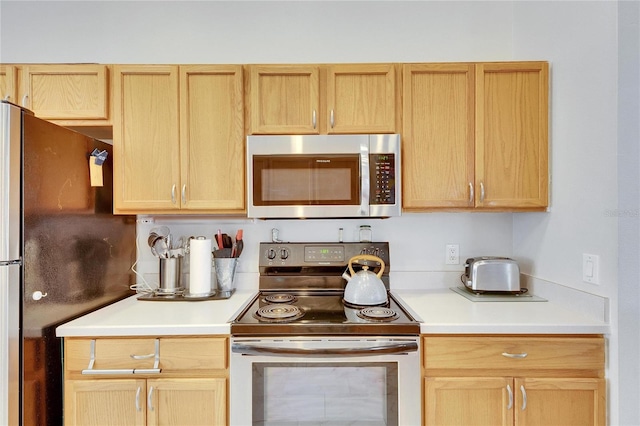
(65, 337, 228, 372)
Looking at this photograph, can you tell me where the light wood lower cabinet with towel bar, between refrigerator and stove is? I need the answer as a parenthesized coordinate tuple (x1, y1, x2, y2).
(64, 337, 229, 426)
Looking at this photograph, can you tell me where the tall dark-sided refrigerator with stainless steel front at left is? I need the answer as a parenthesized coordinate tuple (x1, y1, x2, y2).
(0, 101, 136, 425)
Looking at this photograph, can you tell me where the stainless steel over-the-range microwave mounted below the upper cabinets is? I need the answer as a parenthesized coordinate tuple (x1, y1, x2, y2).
(246, 134, 402, 218)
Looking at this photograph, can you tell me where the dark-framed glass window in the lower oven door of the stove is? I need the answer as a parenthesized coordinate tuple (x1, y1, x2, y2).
(252, 362, 398, 426)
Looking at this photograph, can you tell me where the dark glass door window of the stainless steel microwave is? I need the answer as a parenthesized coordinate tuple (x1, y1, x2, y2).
(253, 154, 360, 206)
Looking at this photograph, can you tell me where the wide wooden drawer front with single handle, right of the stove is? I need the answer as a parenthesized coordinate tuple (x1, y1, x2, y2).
(423, 336, 604, 370)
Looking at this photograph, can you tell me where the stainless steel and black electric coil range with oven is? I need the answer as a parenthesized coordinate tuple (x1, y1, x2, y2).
(230, 242, 421, 426)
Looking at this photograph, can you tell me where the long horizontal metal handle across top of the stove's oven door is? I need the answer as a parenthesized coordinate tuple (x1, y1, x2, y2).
(231, 342, 418, 357)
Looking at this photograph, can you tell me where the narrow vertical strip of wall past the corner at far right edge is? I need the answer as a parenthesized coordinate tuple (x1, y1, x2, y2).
(617, 2, 640, 424)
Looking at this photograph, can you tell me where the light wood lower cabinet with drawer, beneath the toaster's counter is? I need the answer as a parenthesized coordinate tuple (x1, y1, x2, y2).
(423, 335, 606, 426)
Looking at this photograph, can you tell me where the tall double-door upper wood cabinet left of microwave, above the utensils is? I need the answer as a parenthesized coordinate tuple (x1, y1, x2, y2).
(113, 65, 244, 214)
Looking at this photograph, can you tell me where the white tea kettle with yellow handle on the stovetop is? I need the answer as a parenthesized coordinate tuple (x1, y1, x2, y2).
(342, 254, 388, 306)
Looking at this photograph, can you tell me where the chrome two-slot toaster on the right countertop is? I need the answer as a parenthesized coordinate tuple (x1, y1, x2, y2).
(462, 256, 521, 293)
